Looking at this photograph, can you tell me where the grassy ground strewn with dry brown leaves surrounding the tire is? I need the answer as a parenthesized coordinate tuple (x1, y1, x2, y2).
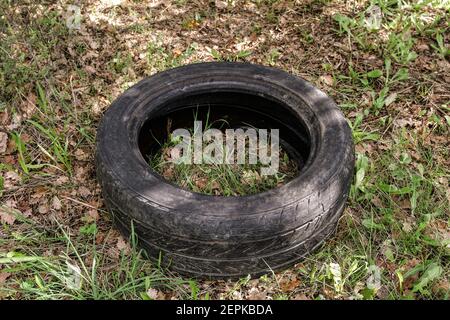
(0, 0, 450, 299)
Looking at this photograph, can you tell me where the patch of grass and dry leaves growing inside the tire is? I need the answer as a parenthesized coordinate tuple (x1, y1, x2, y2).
(149, 127, 299, 196)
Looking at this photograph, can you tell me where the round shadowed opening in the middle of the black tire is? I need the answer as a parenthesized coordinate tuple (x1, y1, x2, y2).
(138, 92, 311, 196)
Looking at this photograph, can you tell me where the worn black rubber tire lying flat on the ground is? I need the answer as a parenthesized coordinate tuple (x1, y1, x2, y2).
(96, 63, 354, 278)
